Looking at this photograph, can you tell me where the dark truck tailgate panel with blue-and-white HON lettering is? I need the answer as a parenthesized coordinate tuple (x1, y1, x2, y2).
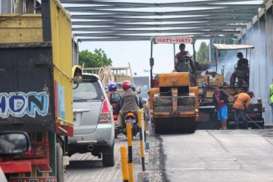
(0, 43, 55, 130)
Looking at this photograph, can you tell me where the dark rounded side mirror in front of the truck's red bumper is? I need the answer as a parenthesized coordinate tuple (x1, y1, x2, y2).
(0, 132, 30, 155)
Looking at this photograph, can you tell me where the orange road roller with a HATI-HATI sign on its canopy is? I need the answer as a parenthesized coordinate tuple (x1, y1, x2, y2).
(149, 36, 199, 134)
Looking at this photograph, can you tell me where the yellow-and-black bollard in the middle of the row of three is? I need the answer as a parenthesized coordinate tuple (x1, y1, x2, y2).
(126, 123, 134, 182)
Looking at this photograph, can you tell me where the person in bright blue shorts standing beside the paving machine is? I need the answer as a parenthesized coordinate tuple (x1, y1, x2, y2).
(213, 87, 228, 129)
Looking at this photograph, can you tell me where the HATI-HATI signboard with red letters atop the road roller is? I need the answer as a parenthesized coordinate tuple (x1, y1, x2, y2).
(154, 36, 192, 44)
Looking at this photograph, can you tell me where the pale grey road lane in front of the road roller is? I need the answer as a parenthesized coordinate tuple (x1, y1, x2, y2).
(161, 130, 273, 182)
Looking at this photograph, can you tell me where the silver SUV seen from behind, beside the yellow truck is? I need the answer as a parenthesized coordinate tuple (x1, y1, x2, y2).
(68, 74, 115, 166)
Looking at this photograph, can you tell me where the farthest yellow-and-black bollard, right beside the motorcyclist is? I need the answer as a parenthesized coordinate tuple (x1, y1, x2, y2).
(137, 110, 146, 171)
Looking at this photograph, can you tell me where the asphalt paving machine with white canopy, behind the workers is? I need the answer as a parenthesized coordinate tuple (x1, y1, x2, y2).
(197, 44, 264, 129)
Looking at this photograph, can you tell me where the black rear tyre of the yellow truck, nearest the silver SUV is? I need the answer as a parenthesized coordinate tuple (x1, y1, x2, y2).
(56, 143, 64, 182)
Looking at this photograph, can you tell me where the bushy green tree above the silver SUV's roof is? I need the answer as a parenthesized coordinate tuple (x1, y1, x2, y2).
(79, 49, 112, 67)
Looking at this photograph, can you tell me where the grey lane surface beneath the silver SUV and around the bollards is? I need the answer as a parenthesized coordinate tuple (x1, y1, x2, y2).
(65, 136, 164, 182)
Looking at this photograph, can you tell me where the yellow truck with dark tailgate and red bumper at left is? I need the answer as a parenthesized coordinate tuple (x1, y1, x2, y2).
(0, 0, 75, 182)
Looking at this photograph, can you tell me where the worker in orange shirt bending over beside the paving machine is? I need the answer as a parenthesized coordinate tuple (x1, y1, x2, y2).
(233, 92, 254, 129)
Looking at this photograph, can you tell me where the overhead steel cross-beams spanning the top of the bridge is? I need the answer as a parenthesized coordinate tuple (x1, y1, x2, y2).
(62, 0, 261, 41)
